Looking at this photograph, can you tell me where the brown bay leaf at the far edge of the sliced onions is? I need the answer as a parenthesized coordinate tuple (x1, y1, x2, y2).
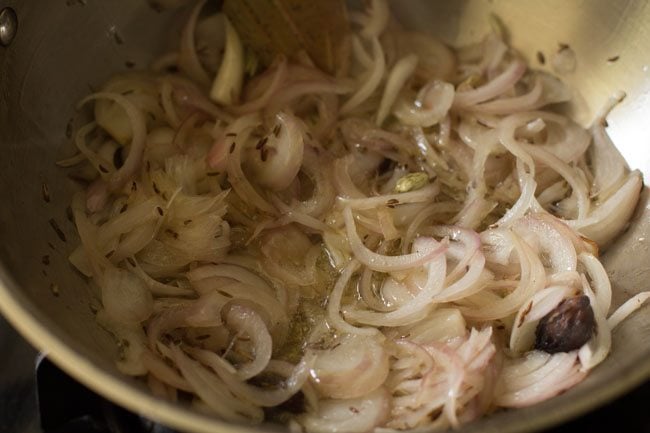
(223, 0, 350, 73)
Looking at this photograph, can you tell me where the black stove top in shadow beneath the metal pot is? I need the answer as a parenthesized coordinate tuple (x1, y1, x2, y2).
(0, 317, 650, 433)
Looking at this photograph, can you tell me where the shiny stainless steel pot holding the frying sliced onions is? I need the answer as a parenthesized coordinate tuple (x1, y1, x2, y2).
(0, 0, 650, 433)
